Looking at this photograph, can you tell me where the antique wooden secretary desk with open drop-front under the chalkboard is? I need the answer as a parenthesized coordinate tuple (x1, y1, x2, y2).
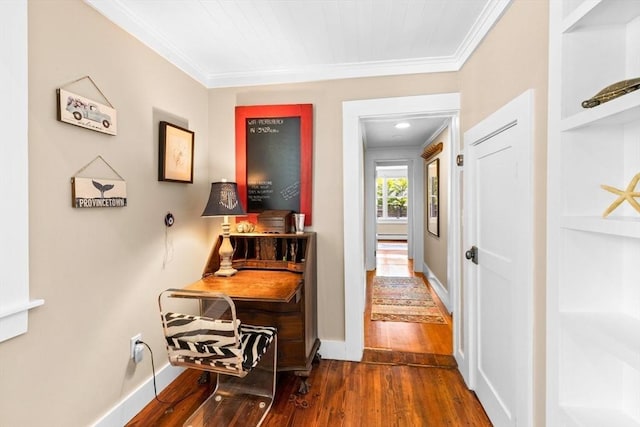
(191, 233, 320, 392)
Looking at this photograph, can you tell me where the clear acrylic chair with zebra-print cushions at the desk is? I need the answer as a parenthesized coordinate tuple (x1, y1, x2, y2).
(158, 289, 277, 427)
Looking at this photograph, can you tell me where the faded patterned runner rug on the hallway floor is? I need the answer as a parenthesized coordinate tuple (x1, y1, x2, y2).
(371, 277, 447, 323)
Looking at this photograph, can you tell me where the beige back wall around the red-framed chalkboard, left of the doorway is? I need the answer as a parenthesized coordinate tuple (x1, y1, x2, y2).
(209, 73, 458, 340)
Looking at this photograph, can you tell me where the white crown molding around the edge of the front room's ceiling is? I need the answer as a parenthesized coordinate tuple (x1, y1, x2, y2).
(84, 0, 511, 89)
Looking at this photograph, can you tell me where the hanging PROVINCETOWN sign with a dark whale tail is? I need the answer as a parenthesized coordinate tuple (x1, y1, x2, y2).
(71, 156, 127, 208)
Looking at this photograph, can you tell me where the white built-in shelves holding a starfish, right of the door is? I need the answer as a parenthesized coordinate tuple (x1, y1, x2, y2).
(546, 0, 640, 427)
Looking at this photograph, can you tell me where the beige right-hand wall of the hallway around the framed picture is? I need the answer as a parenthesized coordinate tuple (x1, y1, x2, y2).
(424, 128, 452, 290)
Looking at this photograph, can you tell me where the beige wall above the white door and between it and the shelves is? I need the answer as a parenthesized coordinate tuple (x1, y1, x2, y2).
(460, 0, 549, 425)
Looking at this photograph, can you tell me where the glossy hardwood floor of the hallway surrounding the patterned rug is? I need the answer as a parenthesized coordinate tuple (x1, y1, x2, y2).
(364, 241, 453, 356)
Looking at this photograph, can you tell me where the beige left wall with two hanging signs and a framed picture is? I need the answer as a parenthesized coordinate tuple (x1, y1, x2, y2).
(0, 0, 213, 427)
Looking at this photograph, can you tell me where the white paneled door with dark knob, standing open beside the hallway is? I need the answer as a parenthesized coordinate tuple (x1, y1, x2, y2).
(464, 92, 533, 427)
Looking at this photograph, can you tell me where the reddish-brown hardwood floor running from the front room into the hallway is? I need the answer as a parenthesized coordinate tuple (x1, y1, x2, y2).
(127, 242, 491, 427)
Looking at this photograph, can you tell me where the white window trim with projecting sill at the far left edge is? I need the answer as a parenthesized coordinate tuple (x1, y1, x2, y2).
(0, 0, 44, 342)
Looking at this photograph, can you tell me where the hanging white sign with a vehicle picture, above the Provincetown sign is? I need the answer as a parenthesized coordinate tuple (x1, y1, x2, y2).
(56, 76, 117, 135)
